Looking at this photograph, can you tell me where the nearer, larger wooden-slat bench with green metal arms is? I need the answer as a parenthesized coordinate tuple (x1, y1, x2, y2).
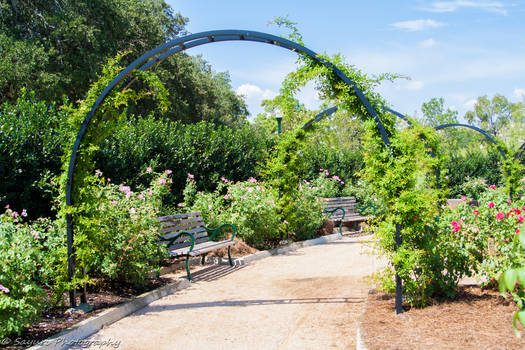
(157, 212, 237, 282)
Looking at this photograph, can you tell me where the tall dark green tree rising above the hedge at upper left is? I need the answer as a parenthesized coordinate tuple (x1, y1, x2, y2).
(0, 0, 247, 125)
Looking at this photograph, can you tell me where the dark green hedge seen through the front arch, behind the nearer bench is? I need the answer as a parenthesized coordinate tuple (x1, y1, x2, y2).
(96, 116, 269, 202)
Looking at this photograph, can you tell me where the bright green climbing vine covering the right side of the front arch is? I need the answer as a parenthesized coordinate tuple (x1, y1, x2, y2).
(276, 19, 464, 305)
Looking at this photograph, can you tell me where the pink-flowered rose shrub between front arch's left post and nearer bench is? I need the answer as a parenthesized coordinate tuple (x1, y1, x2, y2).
(80, 169, 171, 285)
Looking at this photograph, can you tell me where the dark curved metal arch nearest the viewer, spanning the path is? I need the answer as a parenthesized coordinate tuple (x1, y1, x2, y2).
(66, 30, 390, 306)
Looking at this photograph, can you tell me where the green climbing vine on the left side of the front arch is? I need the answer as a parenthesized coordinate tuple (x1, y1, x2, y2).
(59, 55, 169, 292)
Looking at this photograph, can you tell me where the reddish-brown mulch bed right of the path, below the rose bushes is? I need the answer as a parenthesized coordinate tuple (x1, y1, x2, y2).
(361, 285, 525, 350)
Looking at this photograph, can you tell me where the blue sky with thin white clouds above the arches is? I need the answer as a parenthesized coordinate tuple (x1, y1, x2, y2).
(167, 0, 525, 116)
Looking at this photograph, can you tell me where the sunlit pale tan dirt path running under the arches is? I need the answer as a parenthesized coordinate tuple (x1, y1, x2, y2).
(80, 238, 380, 350)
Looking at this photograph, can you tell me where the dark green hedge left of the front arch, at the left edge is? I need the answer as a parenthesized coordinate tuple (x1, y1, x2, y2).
(0, 90, 68, 218)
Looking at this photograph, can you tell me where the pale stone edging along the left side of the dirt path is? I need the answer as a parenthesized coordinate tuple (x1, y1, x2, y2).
(29, 233, 343, 350)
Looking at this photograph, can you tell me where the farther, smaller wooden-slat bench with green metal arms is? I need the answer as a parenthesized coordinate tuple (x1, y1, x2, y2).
(321, 197, 376, 236)
